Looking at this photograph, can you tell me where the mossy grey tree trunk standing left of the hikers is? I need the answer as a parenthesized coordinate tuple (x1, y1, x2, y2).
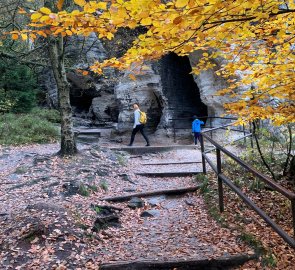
(48, 36, 77, 156)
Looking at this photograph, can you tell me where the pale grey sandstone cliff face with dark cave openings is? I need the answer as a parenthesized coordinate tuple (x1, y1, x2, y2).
(42, 35, 231, 133)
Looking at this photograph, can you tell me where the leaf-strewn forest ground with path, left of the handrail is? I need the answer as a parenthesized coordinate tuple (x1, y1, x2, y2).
(0, 140, 294, 270)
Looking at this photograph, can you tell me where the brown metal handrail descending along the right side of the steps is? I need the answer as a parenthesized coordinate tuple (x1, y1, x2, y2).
(201, 123, 295, 248)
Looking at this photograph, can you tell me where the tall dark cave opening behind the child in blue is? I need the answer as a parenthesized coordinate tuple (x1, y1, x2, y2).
(160, 53, 208, 128)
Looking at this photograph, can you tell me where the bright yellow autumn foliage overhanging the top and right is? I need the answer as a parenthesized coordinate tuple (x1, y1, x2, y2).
(12, 0, 295, 153)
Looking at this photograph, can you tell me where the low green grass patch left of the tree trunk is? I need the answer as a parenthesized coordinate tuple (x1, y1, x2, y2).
(0, 109, 59, 145)
